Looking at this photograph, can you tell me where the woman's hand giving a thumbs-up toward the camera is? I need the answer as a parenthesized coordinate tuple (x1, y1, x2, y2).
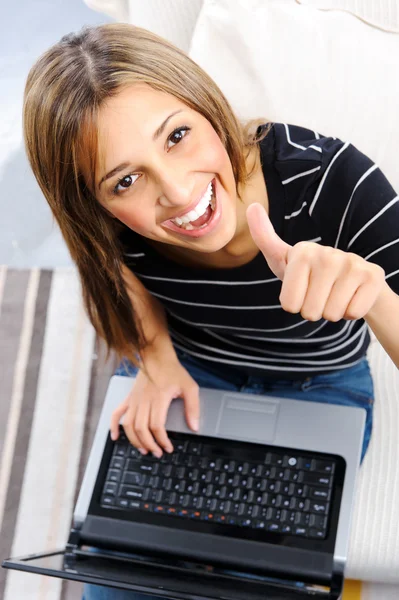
(247, 203, 385, 322)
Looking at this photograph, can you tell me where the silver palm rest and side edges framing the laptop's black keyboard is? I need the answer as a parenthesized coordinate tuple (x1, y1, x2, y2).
(74, 376, 366, 576)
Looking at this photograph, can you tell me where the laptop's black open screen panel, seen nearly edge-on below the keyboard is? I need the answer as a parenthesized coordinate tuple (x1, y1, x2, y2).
(2, 545, 343, 600)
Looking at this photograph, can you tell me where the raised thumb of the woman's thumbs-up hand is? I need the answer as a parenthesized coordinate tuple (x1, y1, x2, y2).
(247, 202, 292, 281)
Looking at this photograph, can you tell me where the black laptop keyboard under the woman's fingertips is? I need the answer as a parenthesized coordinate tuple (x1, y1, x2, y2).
(101, 431, 336, 540)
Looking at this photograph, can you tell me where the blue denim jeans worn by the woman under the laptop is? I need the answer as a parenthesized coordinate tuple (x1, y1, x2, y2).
(82, 351, 374, 600)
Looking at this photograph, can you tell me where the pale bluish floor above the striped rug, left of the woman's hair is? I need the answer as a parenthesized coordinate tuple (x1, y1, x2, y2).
(0, 0, 109, 268)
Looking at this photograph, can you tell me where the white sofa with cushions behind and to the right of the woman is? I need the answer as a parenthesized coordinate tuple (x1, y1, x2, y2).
(85, 0, 399, 600)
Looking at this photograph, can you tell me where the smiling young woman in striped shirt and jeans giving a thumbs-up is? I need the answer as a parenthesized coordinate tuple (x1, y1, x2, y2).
(24, 24, 399, 600)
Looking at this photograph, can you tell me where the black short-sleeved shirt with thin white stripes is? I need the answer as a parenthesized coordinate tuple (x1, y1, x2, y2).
(121, 123, 399, 379)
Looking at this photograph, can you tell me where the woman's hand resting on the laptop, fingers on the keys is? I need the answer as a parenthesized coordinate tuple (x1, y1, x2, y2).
(111, 355, 199, 458)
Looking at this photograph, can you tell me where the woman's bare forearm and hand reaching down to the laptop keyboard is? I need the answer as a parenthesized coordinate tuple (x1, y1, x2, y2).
(111, 266, 199, 457)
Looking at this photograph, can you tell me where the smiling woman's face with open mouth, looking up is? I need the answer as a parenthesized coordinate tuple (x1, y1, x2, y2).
(96, 84, 238, 252)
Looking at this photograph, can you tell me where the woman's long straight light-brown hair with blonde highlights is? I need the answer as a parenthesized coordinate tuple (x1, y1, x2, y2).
(23, 23, 268, 364)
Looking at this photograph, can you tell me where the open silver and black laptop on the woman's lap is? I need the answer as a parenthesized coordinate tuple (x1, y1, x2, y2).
(3, 376, 366, 600)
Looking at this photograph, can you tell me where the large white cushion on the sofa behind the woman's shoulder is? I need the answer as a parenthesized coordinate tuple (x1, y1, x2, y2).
(190, 0, 399, 192)
